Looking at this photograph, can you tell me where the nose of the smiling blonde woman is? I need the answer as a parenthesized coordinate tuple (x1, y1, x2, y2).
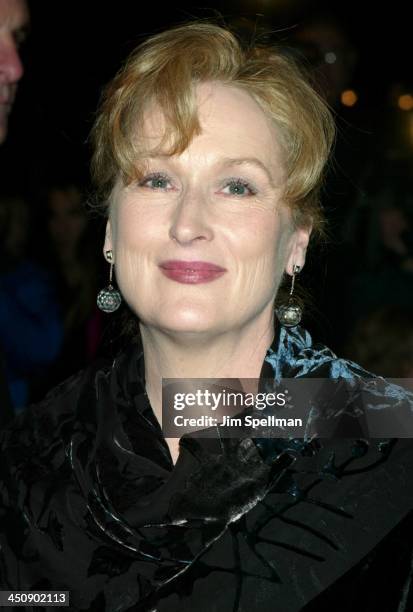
(169, 190, 213, 245)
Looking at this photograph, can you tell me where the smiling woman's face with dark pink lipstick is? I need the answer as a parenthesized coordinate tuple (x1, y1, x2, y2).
(104, 83, 309, 335)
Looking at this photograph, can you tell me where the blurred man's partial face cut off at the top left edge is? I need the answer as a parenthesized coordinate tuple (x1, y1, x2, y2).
(0, 0, 29, 144)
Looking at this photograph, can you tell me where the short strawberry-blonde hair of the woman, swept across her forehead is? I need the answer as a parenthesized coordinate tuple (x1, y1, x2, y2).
(92, 22, 335, 237)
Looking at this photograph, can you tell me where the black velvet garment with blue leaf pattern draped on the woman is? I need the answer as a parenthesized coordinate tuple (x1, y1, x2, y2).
(0, 327, 413, 612)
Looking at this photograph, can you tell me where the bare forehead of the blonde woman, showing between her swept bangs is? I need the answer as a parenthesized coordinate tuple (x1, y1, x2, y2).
(143, 83, 281, 169)
